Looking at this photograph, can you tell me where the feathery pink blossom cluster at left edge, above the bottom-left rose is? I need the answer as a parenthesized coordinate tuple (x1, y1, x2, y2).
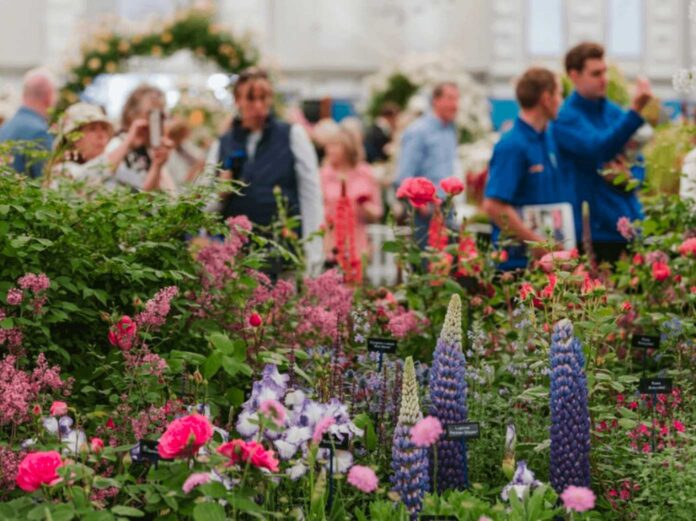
(0, 353, 68, 425)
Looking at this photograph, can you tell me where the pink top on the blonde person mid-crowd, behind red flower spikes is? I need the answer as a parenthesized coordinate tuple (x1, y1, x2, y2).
(320, 163, 384, 260)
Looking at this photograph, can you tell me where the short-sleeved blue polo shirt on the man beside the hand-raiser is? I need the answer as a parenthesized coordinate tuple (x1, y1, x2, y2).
(485, 117, 577, 270)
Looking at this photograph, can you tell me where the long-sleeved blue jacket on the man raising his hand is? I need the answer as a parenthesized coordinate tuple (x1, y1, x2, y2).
(553, 92, 645, 242)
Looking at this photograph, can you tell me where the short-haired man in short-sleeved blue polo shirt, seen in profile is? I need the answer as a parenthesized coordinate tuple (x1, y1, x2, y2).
(483, 67, 573, 270)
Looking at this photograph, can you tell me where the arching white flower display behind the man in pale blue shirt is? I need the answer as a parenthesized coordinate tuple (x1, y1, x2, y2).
(364, 51, 492, 139)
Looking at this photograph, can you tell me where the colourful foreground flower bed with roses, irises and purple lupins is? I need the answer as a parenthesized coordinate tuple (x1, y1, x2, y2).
(0, 175, 696, 520)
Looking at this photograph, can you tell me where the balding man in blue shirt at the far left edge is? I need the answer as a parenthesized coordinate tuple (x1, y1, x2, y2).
(0, 69, 57, 178)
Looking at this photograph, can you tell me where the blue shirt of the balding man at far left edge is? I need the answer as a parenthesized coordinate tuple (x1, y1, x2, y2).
(0, 107, 53, 178)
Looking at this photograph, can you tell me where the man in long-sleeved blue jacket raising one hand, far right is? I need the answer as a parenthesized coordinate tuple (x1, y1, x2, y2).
(554, 42, 652, 262)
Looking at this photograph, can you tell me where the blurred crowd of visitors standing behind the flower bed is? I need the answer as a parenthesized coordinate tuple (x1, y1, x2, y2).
(0, 42, 684, 270)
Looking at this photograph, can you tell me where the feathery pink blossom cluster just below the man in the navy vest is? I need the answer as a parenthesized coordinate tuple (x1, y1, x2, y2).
(196, 215, 252, 289)
